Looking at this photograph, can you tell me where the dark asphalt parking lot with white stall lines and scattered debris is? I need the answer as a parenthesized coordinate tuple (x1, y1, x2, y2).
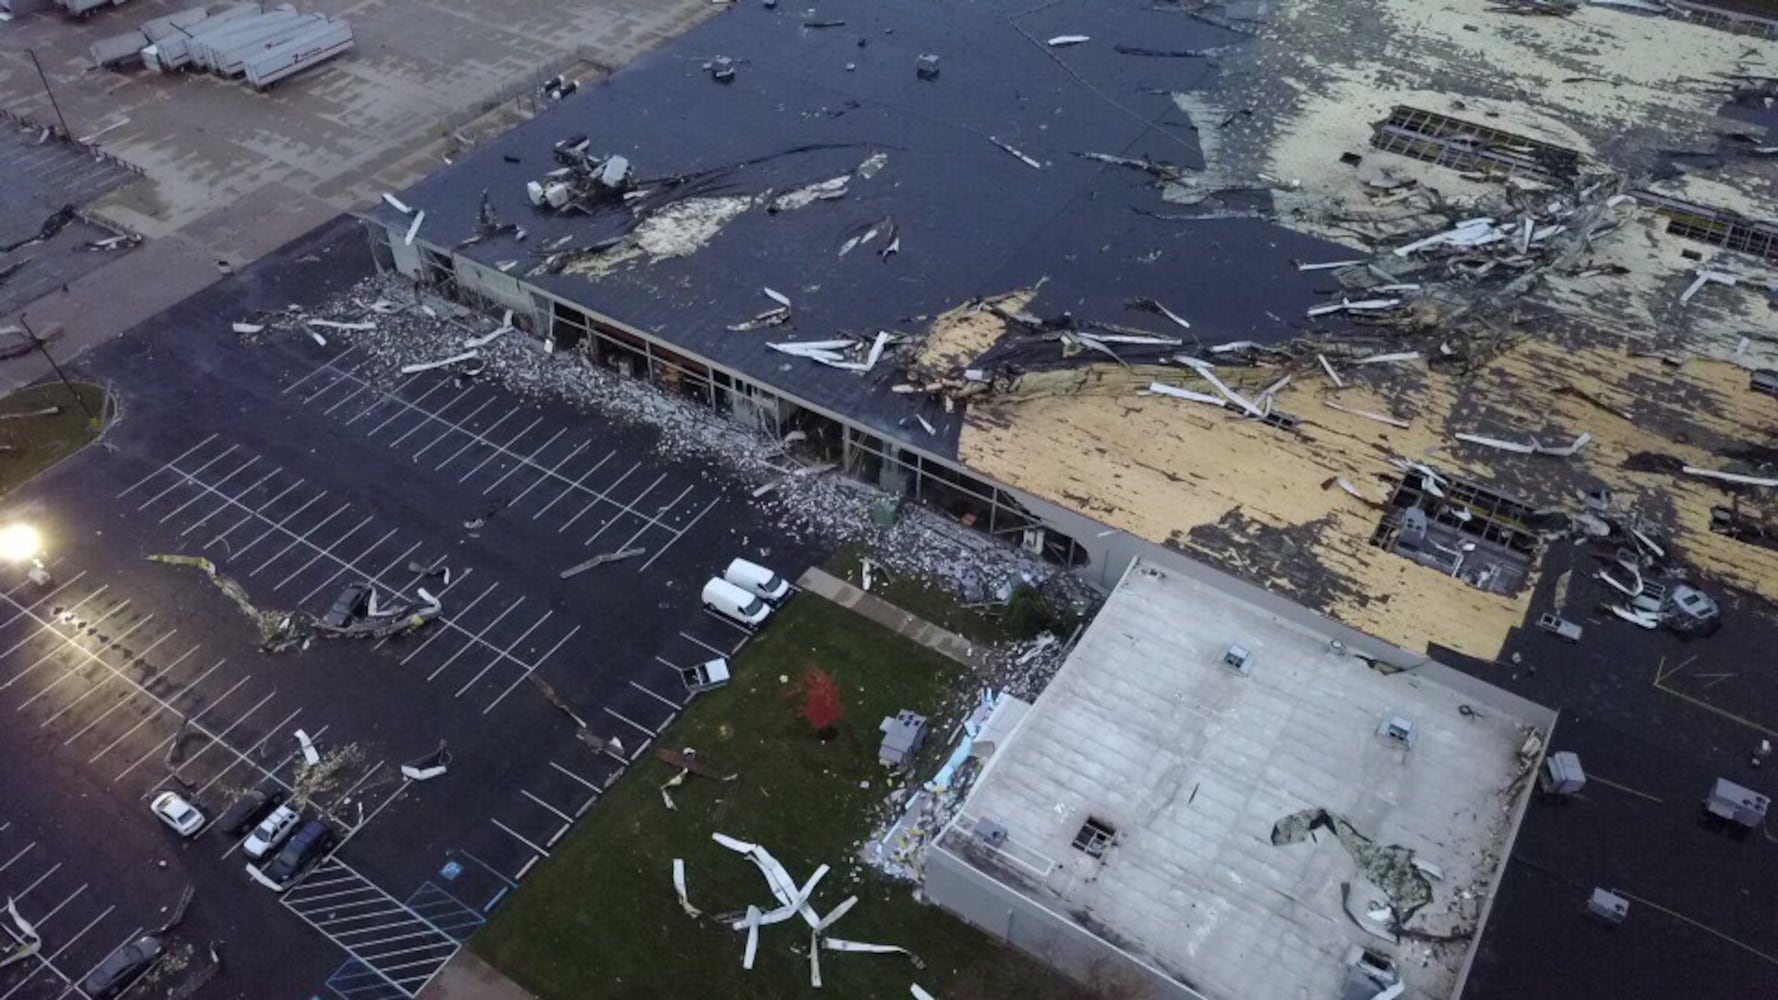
(0, 221, 821, 1000)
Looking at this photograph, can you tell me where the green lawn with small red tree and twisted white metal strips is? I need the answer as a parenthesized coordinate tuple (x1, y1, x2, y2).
(469, 594, 1072, 1000)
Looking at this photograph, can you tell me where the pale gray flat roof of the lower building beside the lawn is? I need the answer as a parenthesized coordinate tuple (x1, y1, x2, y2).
(941, 562, 1547, 1000)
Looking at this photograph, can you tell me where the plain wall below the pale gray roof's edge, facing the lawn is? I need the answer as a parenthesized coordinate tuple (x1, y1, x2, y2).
(925, 847, 1205, 1000)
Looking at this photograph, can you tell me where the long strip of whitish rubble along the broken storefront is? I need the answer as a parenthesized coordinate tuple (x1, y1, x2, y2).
(268, 276, 1099, 637)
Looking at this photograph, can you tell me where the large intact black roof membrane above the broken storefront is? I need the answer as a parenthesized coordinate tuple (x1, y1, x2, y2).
(373, 0, 1344, 456)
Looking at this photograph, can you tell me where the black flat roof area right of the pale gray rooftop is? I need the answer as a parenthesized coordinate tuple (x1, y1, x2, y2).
(1435, 544, 1778, 1000)
